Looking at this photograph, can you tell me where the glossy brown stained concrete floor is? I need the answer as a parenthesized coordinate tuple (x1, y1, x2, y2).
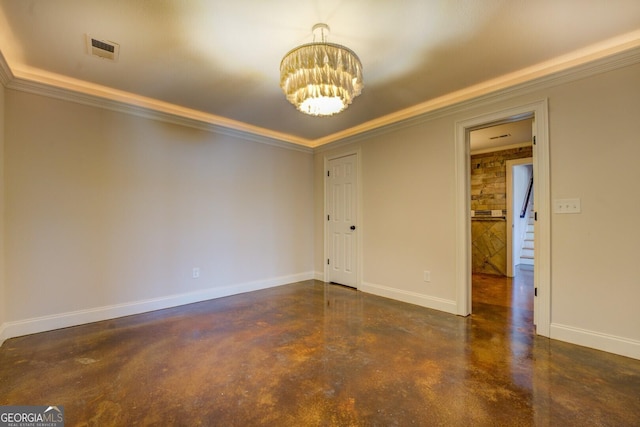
(0, 276, 640, 426)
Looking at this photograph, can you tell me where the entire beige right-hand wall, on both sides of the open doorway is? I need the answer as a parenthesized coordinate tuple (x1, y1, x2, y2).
(315, 58, 640, 358)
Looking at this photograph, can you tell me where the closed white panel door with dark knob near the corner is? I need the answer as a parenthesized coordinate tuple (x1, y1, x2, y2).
(326, 154, 358, 287)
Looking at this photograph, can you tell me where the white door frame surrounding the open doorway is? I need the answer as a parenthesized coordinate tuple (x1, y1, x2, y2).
(455, 99, 551, 337)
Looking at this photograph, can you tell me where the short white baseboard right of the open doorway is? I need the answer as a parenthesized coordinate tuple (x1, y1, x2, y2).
(549, 323, 640, 359)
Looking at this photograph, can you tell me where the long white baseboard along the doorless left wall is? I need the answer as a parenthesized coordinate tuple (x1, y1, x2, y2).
(0, 272, 314, 345)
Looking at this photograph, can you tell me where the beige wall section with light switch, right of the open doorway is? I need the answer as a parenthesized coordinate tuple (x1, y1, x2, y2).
(549, 64, 640, 342)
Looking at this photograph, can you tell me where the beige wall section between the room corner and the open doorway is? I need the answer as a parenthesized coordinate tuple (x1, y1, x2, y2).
(315, 117, 456, 310)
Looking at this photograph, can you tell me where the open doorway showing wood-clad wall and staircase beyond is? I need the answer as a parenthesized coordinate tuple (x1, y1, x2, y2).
(469, 118, 535, 320)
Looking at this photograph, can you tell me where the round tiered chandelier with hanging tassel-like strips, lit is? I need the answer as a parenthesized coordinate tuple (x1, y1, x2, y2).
(280, 24, 364, 116)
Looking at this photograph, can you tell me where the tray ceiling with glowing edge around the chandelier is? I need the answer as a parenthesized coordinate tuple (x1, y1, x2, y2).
(0, 0, 640, 147)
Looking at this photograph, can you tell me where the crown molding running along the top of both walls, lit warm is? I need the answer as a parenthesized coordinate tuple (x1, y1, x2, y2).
(0, 30, 640, 153)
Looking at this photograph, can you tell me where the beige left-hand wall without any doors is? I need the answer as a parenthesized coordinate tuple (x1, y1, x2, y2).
(5, 90, 313, 334)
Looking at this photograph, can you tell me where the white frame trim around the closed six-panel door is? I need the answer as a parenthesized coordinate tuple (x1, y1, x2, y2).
(322, 147, 364, 289)
